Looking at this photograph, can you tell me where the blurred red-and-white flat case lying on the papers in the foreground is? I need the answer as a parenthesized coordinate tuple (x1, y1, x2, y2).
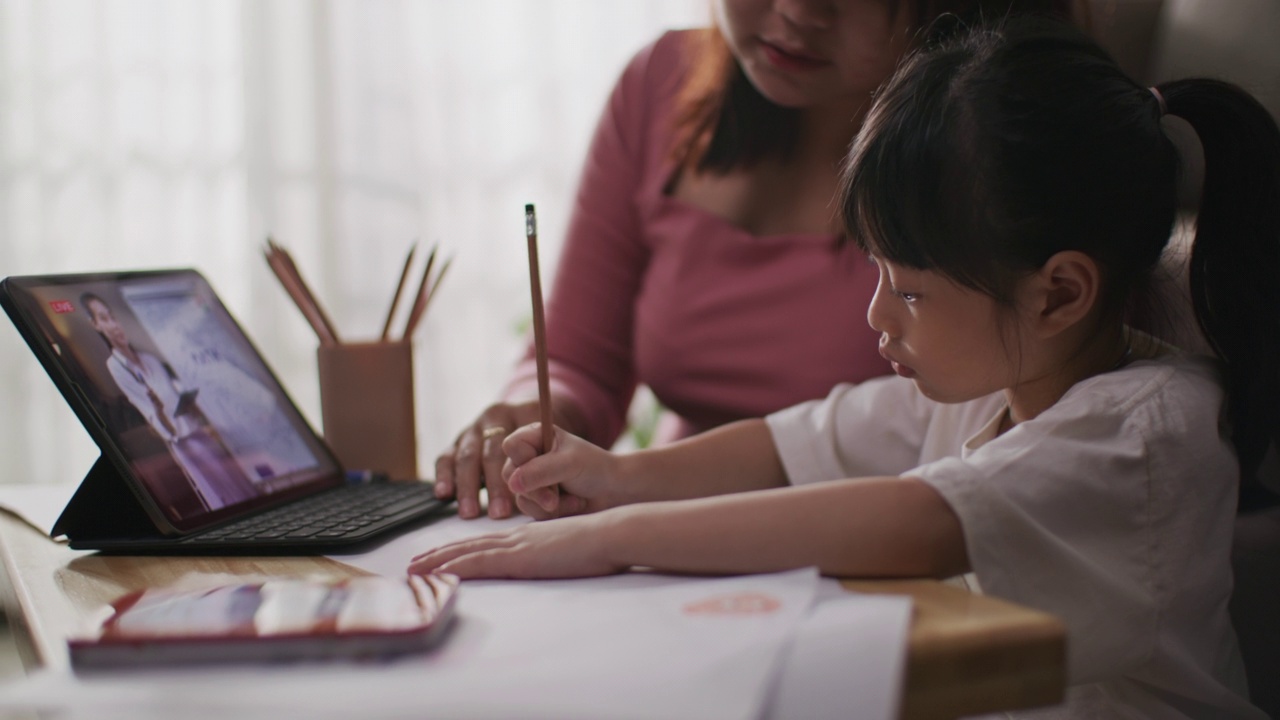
(67, 574, 458, 671)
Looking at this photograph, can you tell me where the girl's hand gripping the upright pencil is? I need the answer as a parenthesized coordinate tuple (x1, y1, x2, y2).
(502, 423, 618, 520)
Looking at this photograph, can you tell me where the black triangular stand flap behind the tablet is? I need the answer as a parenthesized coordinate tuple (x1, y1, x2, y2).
(49, 455, 161, 542)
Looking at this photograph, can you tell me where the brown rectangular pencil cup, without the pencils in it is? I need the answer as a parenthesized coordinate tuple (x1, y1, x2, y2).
(316, 341, 417, 479)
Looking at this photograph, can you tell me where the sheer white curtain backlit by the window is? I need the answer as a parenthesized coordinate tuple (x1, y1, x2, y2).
(0, 0, 708, 482)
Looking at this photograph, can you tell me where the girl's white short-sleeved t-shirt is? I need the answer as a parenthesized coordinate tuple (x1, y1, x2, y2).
(768, 356, 1265, 719)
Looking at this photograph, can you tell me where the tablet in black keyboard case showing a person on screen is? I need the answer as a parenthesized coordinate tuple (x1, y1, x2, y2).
(0, 269, 451, 555)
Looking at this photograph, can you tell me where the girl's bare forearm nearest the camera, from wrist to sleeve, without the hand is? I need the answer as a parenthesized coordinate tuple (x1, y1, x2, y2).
(602, 477, 969, 577)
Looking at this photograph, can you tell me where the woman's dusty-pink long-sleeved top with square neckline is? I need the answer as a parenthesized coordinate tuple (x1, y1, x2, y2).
(507, 31, 888, 447)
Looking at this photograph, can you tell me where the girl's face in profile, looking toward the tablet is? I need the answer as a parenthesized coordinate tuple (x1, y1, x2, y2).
(867, 259, 1020, 402)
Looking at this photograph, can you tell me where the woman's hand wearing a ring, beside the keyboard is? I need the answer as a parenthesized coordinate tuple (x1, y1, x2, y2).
(435, 400, 538, 519)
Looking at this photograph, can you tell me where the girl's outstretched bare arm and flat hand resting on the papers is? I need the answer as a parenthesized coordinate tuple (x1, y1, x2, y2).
(408, 477, 969, 578)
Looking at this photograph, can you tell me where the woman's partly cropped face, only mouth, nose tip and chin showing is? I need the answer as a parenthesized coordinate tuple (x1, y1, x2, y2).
(716, 0, 911, 108)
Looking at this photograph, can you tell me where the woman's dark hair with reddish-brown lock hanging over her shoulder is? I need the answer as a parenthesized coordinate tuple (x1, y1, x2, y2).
(672, 0, 1083, 173)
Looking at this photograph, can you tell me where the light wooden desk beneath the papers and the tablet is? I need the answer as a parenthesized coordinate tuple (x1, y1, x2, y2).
(0, 511, 1065, 720)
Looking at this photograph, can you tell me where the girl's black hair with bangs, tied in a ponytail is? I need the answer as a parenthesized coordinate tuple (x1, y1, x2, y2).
(841, 20, 1280, 503)
